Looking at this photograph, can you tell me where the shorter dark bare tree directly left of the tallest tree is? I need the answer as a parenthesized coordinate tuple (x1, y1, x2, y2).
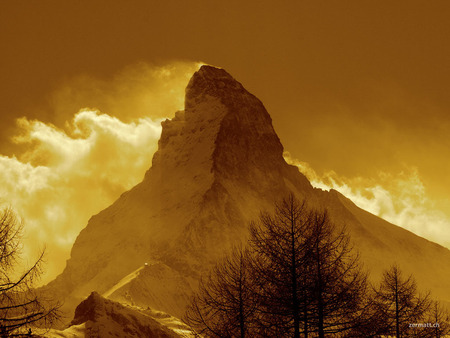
(184, 248, 257, 338)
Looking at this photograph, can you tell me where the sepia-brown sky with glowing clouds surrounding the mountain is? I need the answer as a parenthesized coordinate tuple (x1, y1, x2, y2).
(0, 0, 450, 278)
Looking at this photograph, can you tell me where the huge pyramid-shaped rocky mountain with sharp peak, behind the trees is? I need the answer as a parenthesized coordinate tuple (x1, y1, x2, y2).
(48, 66, 450, 316)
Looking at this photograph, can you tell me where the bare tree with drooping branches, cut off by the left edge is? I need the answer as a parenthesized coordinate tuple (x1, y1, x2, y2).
(0, 208, 58, 337)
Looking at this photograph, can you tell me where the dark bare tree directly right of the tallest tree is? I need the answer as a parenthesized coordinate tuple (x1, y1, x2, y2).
(308, 211, 367, 337)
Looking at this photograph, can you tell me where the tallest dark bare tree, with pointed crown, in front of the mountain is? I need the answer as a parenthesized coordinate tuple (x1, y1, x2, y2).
(250, 195, 311, 337)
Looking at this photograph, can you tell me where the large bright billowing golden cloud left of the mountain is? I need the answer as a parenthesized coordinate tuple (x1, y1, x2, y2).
(0, 110, 161, 281)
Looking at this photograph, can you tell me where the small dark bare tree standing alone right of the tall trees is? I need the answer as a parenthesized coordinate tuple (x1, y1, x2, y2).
(375, 265, 430, 338)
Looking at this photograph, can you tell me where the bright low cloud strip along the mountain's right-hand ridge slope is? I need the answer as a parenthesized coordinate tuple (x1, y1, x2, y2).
(284, 152, 450, 248)
